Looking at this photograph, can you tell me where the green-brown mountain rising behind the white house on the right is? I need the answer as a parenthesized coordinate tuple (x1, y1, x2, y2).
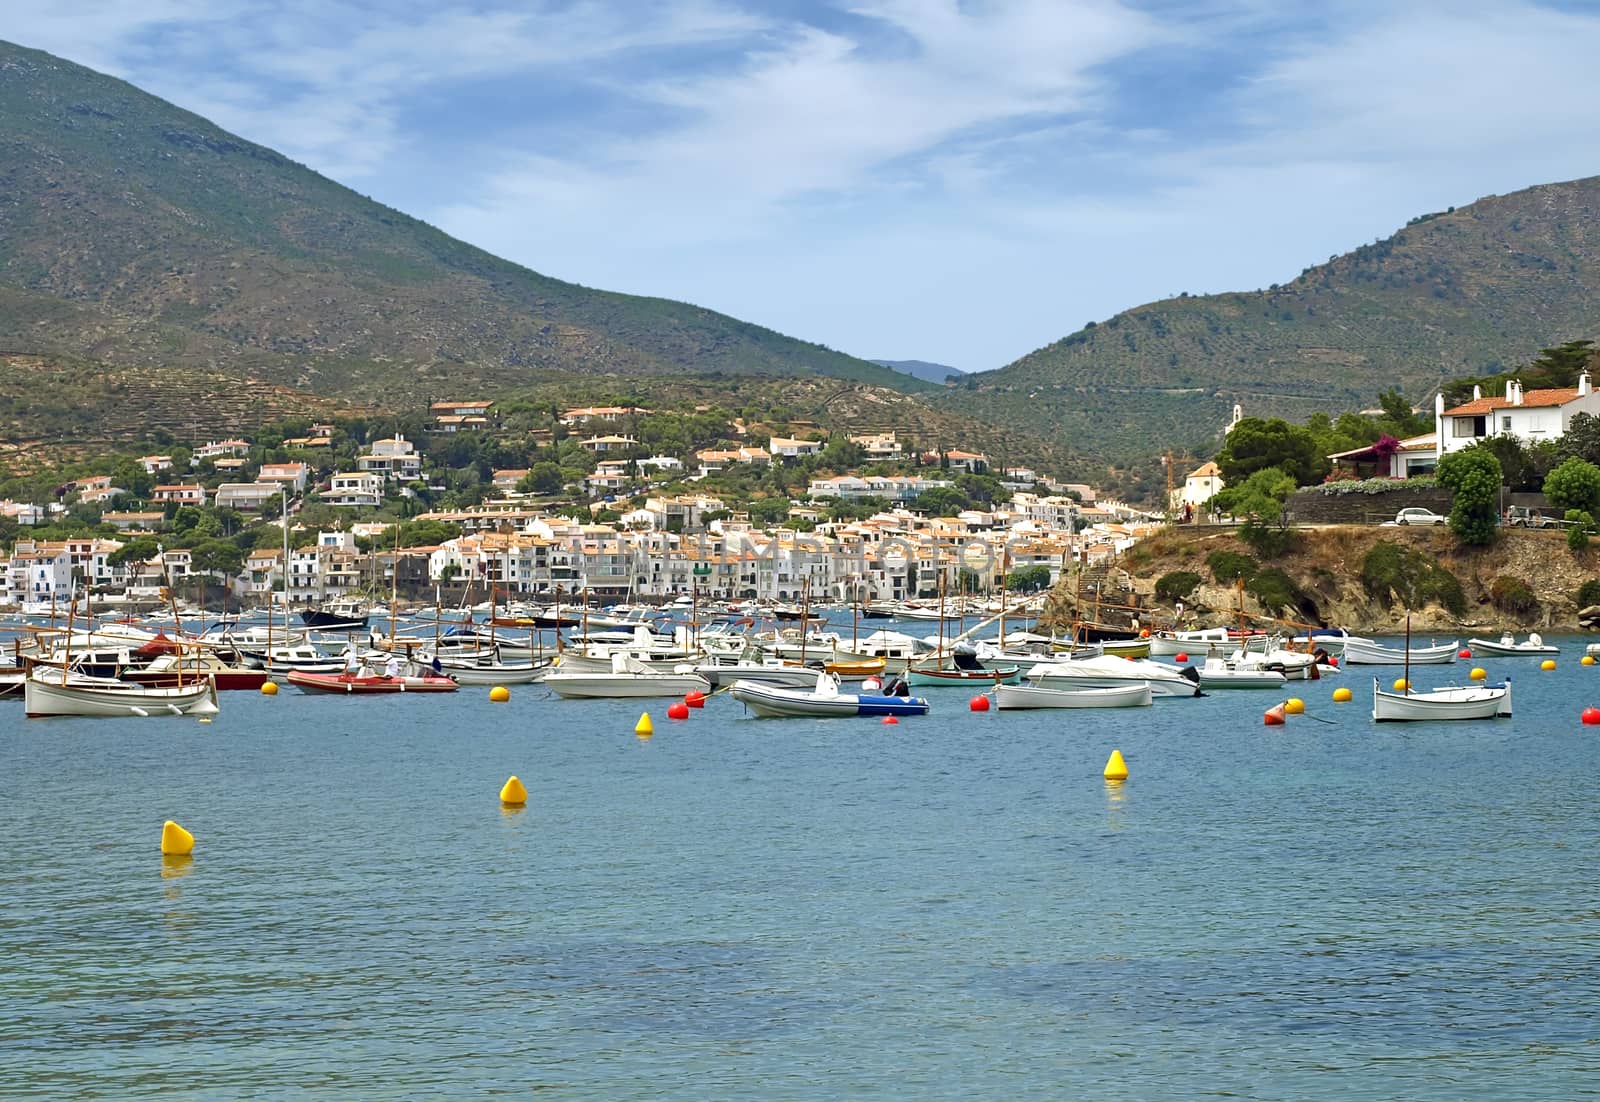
(936, 178, 1600, 462)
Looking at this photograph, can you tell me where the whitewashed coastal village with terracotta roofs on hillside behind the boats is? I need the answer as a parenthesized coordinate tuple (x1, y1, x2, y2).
(0, 400, 1162, 613)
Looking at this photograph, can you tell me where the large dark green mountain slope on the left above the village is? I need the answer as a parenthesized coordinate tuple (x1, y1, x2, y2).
(0, 43, 928, 406)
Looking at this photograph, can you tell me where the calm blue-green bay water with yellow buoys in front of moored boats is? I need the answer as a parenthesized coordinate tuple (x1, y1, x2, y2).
(0, 640, 1600, 1099)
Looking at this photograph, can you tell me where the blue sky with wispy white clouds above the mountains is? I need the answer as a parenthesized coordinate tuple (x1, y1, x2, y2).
(12, 0, 1600, 371)
